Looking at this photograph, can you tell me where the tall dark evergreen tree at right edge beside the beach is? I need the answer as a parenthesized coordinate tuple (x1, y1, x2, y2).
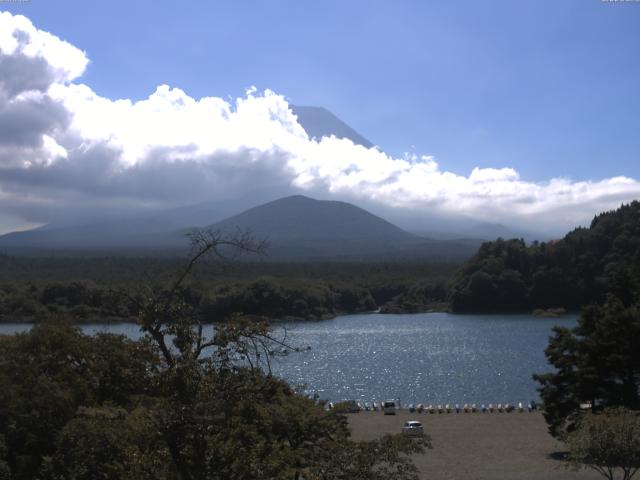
(534, 297, 640, 438)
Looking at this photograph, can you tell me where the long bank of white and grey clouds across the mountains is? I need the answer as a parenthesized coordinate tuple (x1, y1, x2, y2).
(0, 12, 640, 235)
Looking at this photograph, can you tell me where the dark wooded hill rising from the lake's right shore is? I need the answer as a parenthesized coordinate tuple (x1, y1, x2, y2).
(449, 201, 640, 312)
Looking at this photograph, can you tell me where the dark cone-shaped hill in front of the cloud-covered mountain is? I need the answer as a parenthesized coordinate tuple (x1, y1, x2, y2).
(212, 195, 478, 260)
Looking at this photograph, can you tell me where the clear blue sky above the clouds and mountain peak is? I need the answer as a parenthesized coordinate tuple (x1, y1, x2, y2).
(2, 0, 640, 181)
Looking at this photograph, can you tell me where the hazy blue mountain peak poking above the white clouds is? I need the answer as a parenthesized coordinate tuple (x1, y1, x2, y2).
(290, 105, 374, 148)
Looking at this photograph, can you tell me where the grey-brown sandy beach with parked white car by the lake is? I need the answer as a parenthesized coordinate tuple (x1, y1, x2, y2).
(349, 411, 601, 480)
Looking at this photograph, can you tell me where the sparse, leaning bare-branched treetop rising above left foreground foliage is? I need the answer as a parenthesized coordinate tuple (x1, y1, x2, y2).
(130, 229, 294, 373)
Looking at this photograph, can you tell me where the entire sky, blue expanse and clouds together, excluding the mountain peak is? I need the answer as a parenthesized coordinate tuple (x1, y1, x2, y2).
(0, 0, 640, 233)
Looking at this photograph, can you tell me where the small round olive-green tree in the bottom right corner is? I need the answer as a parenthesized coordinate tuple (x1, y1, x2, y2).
(567, 409, 640, 480)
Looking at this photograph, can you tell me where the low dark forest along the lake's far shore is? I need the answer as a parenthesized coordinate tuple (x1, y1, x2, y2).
(0, 257, 453, 322)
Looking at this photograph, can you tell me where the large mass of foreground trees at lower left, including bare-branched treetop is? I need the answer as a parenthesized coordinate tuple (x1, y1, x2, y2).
(0, 232, 428, 480)
